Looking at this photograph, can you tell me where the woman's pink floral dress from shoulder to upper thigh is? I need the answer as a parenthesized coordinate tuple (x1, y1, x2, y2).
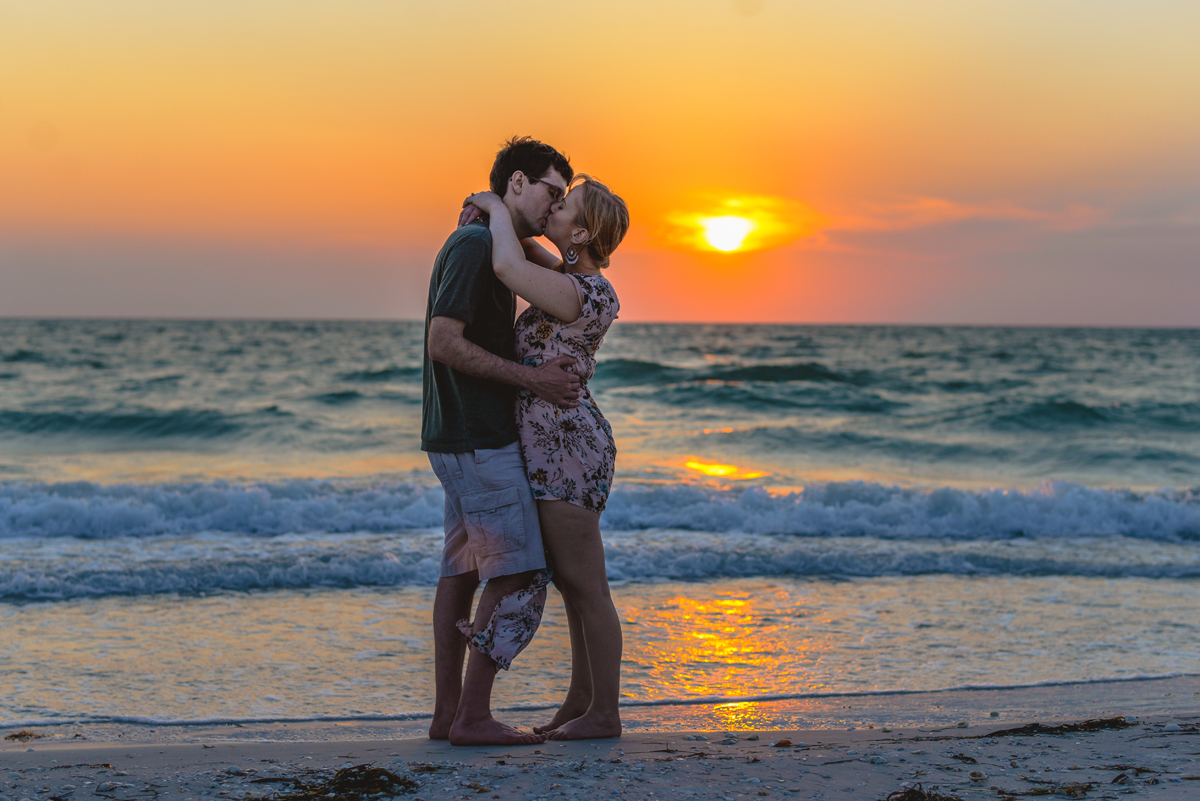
(516, 273, 620, 512)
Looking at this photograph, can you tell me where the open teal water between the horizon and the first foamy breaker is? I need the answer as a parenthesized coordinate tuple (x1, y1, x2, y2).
(0, 320, 1200, 489)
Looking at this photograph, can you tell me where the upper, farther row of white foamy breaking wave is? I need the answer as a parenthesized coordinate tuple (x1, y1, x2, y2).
(0, 481, 1200, 542)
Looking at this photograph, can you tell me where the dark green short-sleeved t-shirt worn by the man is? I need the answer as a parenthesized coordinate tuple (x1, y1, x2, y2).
(421, 223, 517, 453)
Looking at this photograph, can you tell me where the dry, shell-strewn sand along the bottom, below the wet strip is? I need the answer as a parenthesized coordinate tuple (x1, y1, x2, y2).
(0, 715, 1200, 801)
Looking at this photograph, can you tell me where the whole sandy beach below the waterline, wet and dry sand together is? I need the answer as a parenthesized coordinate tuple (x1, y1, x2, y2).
(0, 676, 1200, 801)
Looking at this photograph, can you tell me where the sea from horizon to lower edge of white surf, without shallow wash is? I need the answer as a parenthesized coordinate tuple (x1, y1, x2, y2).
(0, 320, 1200, 600)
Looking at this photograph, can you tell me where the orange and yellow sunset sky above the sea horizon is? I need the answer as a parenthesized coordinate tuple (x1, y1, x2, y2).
(0, 0, 1200, 326)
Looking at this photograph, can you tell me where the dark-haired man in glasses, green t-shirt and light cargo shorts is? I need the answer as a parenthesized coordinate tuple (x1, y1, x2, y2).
(421, 137, 580, 745)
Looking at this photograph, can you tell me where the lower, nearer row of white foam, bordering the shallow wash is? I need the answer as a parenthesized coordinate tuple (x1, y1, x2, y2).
(0, 530, 1200, 601)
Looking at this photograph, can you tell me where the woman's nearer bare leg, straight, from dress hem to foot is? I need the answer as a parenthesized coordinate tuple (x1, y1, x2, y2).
(538, 501, 622, 740)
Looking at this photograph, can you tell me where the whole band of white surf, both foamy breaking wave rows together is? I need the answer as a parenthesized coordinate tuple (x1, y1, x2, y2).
(0, 482, 1200, 600)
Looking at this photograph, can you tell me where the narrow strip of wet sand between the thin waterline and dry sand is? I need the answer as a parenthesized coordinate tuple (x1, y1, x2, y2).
(0, 674, 1200, 753)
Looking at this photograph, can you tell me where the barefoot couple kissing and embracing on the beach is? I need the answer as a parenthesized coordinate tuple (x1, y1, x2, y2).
(421, 137, 629, 745)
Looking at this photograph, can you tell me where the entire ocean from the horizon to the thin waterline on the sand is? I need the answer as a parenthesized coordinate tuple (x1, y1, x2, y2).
(0, 320, 1200, 727)
